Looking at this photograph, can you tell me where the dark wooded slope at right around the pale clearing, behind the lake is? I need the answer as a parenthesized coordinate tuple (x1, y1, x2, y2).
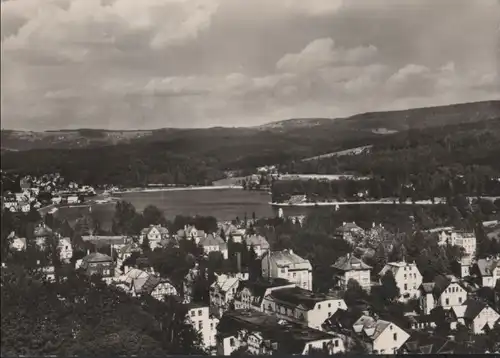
(273, 120, 500, 200)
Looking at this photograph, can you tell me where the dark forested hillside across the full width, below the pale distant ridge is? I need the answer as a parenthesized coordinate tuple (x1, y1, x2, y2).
(2, 102, 500, 186)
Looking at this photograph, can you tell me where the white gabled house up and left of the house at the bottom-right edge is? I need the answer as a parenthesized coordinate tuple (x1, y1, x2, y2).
(419, 275, 467, 314)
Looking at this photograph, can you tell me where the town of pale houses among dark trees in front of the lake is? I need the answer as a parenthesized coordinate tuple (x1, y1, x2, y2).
(2, 171, 500, 355)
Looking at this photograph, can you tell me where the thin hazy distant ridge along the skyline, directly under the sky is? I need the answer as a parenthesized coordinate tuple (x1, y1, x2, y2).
(1, 101, 500, 154)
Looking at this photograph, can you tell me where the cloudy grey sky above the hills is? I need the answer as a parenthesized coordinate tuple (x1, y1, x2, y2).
(1, 0, 500, 131)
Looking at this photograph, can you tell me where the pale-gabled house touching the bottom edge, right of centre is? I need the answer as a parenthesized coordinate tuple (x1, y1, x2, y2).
(353, 315, 410, 354)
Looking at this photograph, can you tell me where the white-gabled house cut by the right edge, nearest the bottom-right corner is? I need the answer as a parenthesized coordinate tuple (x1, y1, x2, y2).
(451, 299, 500, 334)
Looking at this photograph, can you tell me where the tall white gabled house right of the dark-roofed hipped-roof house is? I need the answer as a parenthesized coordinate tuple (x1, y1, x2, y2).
(379, 261, 422, 301)
